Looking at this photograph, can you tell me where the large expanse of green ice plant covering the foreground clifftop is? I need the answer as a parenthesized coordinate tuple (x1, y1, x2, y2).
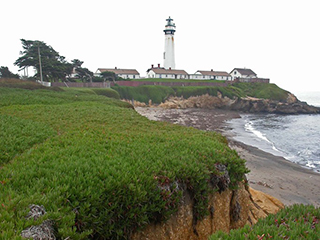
(0, 80, 247, 239)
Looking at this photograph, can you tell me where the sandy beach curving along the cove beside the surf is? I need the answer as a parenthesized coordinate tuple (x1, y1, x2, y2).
(135, 107, 320, 207)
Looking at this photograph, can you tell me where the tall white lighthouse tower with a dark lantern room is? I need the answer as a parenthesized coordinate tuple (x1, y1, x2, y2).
(163, 17, 176, 69)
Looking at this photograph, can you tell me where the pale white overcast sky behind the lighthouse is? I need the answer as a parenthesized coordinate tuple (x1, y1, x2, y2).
(0, 0, 320, 93)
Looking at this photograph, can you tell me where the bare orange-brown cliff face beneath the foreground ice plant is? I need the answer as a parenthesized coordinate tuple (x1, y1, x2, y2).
(131, 183, 284, 240)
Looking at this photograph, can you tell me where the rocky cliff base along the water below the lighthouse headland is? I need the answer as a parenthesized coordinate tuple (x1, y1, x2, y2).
(153, 93, 320, 114)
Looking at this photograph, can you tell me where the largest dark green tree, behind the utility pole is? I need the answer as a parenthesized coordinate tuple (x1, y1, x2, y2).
(14, 39, 72, 81)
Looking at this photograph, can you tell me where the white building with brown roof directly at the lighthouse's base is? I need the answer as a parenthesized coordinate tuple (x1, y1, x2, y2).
(147, 64, 189, 79)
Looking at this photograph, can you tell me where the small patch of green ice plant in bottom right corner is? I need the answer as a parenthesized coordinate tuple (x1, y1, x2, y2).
(210, 205, 320, 240)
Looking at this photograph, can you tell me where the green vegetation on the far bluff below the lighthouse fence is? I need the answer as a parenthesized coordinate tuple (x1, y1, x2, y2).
(113, 83, 289, 103)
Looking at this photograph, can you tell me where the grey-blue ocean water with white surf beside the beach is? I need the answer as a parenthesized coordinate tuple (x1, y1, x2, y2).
(227, 92, 320, 173)
